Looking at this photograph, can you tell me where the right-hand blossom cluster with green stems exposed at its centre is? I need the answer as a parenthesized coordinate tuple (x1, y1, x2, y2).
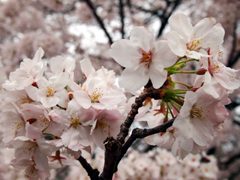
(110, 13, 240, 156)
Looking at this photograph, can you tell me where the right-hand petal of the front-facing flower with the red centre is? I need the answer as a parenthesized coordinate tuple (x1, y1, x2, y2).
(152, 41, 177, 67)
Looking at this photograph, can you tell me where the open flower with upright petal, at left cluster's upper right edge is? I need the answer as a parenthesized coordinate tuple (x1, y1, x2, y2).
(70, 59, 126, 109)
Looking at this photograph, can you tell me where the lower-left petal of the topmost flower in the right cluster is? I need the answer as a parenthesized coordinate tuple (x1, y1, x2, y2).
(166, 31, 187, 57)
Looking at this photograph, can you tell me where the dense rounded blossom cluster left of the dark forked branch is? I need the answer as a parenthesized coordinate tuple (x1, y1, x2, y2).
(0, 49, 126, 179)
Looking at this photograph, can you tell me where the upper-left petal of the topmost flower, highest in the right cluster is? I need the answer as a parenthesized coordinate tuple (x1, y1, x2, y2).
(168, 13, 193, 40)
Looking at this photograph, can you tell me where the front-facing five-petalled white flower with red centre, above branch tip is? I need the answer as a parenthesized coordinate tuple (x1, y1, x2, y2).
(109, 27, 177, 92)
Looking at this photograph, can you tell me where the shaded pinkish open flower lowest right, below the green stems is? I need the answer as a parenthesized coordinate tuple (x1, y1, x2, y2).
(173, 90, 228, 152)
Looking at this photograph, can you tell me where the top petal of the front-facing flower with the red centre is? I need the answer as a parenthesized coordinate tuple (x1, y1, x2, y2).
(130, 27, 154, 51)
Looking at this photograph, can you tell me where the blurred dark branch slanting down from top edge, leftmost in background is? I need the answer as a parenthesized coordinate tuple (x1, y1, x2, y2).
(84, 0, 113, 45)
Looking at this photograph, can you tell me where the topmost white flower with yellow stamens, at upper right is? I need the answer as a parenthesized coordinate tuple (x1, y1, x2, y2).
(167, 13, 225, 59)
